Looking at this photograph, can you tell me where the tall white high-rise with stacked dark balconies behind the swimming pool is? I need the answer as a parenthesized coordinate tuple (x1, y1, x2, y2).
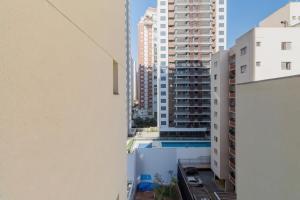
(157, 0, 227, 137)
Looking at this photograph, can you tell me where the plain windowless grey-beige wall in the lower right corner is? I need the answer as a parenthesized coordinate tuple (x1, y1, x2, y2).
(236, 76, 300, 200)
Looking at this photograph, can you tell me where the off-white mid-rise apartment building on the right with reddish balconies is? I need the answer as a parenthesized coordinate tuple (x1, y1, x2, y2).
(211, 2, 300, 194)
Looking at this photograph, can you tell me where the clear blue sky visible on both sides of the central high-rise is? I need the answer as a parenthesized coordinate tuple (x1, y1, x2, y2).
(131, 0, 290, 60)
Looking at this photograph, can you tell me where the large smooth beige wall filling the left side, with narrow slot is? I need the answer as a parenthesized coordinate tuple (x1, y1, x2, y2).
(0, 0, 127, 200)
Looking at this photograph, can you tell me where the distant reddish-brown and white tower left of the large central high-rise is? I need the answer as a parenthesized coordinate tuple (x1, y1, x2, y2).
(138, 8, 157, 116)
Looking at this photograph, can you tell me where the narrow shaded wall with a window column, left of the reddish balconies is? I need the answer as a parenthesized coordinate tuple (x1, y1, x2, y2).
(211, 51, 229, 180)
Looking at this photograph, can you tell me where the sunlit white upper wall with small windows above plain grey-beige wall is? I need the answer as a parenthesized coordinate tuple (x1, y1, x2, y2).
(231, 27, 300, 83)
